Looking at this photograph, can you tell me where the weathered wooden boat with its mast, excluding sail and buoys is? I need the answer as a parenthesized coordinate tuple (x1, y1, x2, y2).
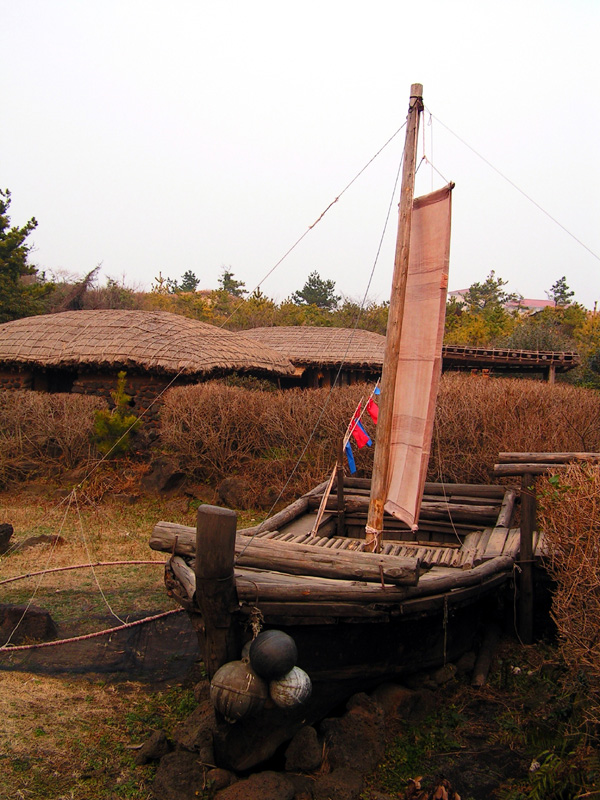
(150, 84, 537, 770)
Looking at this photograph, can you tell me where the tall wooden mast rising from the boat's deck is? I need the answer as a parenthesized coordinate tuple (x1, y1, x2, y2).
(365, 83, 423, 552)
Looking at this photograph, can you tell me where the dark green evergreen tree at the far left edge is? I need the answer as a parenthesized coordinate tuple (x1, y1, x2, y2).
(0, 189, 54, 323)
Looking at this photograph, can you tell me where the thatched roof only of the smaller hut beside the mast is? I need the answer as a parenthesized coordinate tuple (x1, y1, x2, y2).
(244, 326, 385, 369)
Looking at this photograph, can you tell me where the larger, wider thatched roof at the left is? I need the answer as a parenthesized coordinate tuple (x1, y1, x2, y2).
(0, 310, 293, 375)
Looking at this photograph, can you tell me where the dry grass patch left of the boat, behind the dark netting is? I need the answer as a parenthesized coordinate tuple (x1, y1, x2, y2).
(0, 493, 194, 635)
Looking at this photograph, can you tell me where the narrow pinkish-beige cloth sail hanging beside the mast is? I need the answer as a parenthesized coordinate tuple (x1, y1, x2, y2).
(385, 184, 453, 528)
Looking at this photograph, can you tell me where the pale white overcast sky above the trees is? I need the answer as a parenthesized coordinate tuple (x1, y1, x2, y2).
(0, 0, 600, 308)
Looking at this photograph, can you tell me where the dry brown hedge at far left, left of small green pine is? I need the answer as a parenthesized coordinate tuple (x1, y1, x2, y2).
(0, 391, 106, 484)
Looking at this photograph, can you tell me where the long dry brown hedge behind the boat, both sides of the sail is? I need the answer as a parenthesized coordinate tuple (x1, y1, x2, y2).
(161, 373, 600, 495)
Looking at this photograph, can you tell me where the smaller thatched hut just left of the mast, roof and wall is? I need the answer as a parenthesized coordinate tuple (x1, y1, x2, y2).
(244, 326, 385, 386)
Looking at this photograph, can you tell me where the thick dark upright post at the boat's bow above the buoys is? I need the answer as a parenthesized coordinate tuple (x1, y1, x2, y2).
(196, 505, 239, 678)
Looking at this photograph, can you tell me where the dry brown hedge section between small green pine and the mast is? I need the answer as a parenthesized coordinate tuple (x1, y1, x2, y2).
(161, 382, 368, 494)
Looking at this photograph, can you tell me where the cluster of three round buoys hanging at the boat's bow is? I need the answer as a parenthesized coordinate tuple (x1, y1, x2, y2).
(210, 630, 312, 722)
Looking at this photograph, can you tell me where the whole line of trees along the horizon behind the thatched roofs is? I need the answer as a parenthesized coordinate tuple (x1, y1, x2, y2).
(0, 190, 600, 388)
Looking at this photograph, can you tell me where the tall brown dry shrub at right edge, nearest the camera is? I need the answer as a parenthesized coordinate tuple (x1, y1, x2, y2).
(538, 464, 600, 725)
